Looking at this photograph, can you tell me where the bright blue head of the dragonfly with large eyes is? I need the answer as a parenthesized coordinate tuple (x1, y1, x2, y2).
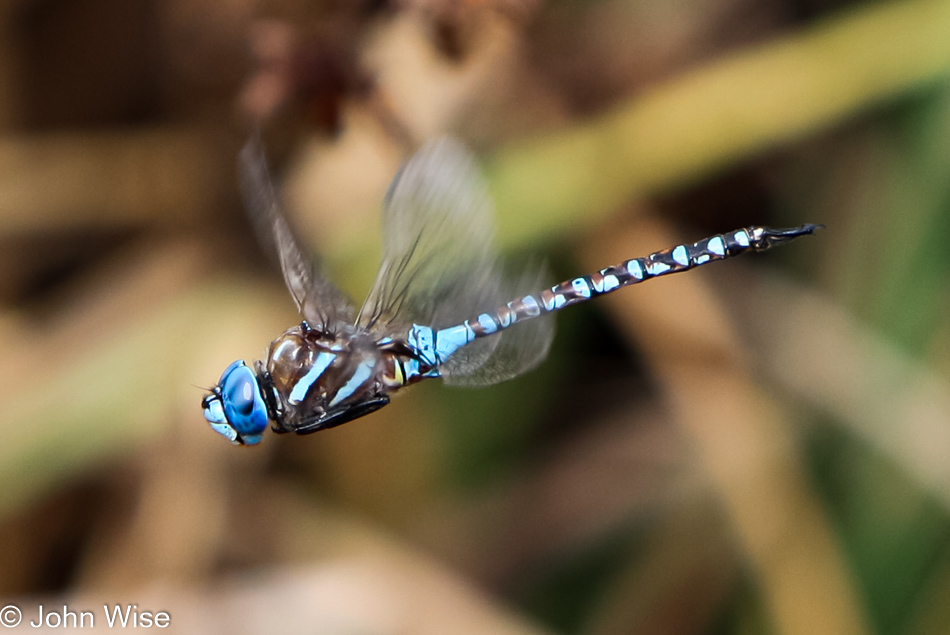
(201, 359, 268, 445)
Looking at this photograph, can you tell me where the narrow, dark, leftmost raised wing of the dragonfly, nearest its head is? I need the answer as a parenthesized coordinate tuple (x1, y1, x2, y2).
(238, 134, 353, 332)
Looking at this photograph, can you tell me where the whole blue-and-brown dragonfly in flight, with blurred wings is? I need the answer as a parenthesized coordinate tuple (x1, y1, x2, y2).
(201, 135, 821, 446)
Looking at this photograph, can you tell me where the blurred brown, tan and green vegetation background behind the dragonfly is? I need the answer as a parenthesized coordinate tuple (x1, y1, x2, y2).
(0, 0, 950, 635)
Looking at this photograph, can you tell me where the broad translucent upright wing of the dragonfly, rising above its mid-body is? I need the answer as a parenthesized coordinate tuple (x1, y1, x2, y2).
(359, 139, 498, 332)
